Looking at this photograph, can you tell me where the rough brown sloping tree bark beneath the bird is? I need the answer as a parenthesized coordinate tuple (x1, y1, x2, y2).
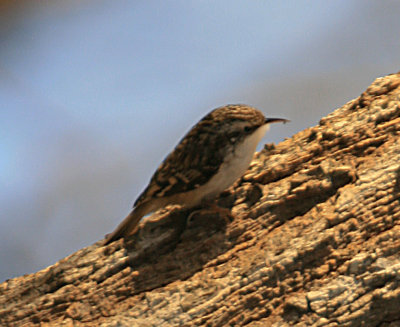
(0, 74, 400, 327)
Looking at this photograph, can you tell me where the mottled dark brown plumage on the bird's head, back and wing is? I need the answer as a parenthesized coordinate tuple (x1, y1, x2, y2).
(134, 105, 265, 207)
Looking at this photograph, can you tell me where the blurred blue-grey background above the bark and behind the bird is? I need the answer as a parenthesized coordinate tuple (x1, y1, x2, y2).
(0, 0, 400, 281)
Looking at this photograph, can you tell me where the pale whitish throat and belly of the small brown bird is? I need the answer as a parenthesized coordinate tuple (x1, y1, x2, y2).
(187, 124, 269, 206)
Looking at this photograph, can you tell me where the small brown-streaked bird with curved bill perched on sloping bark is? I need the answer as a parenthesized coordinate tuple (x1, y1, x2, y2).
(104, 104, 288, 245)
